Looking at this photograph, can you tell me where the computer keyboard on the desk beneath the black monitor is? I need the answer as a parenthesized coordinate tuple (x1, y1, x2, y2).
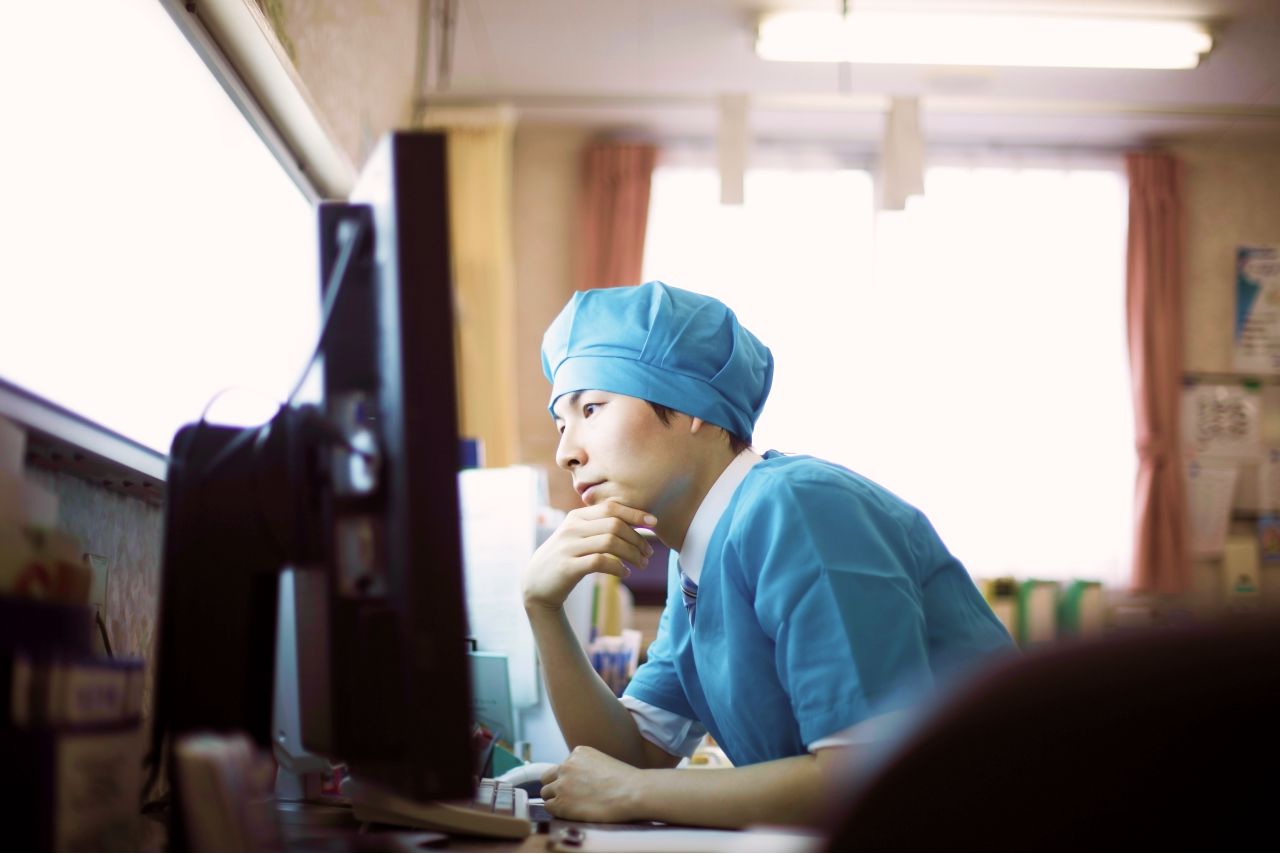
(342, 777, 534, 839)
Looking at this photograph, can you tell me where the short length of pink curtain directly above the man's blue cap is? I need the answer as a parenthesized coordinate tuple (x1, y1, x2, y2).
(575, 142, 658, 291)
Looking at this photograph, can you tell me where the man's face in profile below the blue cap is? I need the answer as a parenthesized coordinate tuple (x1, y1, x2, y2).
(554, 391, 694, 519)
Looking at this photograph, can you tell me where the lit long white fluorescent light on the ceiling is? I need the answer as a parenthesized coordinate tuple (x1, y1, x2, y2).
(755, 12, 1213, 68)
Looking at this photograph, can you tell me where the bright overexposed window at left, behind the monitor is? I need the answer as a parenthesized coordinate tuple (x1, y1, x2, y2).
(0, 0, 319, 453)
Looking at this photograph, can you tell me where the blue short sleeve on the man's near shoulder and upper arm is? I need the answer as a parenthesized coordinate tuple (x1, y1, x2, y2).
(733, 476, 932, 744)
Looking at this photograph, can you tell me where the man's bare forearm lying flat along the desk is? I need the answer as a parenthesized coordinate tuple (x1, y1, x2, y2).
(631, 750, 847, 828)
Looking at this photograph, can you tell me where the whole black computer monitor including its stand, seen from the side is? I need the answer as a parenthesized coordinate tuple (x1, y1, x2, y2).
(152, 133, 474, 829)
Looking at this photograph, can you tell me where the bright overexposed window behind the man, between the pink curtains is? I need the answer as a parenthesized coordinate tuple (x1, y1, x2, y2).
(644, 156, 1135, 584)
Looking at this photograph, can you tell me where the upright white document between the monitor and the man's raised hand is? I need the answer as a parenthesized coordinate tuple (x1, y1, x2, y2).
(458, 466, 545, 708)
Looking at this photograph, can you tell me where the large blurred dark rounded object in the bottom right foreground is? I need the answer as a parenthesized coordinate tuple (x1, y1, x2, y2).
(828, 613, 1280, 851)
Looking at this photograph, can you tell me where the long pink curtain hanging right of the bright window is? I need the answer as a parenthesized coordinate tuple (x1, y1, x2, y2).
(1125, 152, 1190, 593)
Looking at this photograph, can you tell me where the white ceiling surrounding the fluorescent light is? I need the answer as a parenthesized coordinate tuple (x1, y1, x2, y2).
(425, 0, 1280, 147)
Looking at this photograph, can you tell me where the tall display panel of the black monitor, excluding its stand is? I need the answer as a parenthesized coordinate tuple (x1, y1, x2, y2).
(302, 133, 472, 799)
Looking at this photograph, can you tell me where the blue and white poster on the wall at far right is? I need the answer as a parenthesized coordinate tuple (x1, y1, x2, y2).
(1235, 246, 1280, 374)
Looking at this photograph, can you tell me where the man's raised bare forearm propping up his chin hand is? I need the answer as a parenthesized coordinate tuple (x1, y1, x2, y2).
(527, 607, 677, 768)
